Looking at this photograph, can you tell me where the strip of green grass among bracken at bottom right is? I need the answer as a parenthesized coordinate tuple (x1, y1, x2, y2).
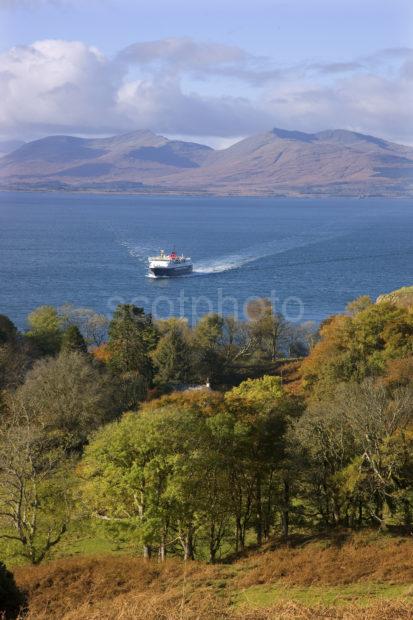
(233, 582, 412, 607)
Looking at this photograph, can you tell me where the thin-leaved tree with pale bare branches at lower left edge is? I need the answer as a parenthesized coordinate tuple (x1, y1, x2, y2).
(0, 404, 70, 564)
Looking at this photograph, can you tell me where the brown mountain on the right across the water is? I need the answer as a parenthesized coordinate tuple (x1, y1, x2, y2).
(166, 129, 413, 195)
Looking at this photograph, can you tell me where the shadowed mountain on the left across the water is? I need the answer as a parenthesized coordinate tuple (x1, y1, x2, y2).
(0, 131, 212, 189)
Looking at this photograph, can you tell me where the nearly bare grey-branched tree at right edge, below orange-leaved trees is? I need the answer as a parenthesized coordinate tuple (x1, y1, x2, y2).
(295, 379, 413, 527)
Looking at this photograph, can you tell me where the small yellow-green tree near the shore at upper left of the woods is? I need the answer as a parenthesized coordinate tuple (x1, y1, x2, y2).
(27, 306, 62, 355)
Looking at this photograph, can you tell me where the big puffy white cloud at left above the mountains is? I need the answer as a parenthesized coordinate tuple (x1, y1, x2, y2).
(0, 40, 122, 133)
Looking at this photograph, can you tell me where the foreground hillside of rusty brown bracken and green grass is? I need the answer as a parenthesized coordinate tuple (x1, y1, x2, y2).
(15, 532, 413, 620)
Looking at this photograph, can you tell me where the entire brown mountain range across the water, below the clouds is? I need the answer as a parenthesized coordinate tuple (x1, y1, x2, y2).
(0, 129, 413, 196)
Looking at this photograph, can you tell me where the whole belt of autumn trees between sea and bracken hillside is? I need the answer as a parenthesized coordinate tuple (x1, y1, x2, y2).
(0, 298, 413, 563)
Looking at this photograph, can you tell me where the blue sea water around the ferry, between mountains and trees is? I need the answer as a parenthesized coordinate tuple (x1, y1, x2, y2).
(0, 192, 413, 328)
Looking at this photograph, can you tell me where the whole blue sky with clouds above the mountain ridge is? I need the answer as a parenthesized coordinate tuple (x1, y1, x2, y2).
(0, 0, 413, 148)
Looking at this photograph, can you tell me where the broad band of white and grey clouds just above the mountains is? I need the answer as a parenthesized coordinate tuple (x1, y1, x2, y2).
(0, 38, 413, 143)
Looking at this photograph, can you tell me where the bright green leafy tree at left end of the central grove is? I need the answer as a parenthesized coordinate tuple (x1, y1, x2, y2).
(81, 412, 192, 557)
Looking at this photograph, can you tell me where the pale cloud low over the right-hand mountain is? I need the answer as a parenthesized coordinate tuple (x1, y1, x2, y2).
(265, 61, 413, 144)
